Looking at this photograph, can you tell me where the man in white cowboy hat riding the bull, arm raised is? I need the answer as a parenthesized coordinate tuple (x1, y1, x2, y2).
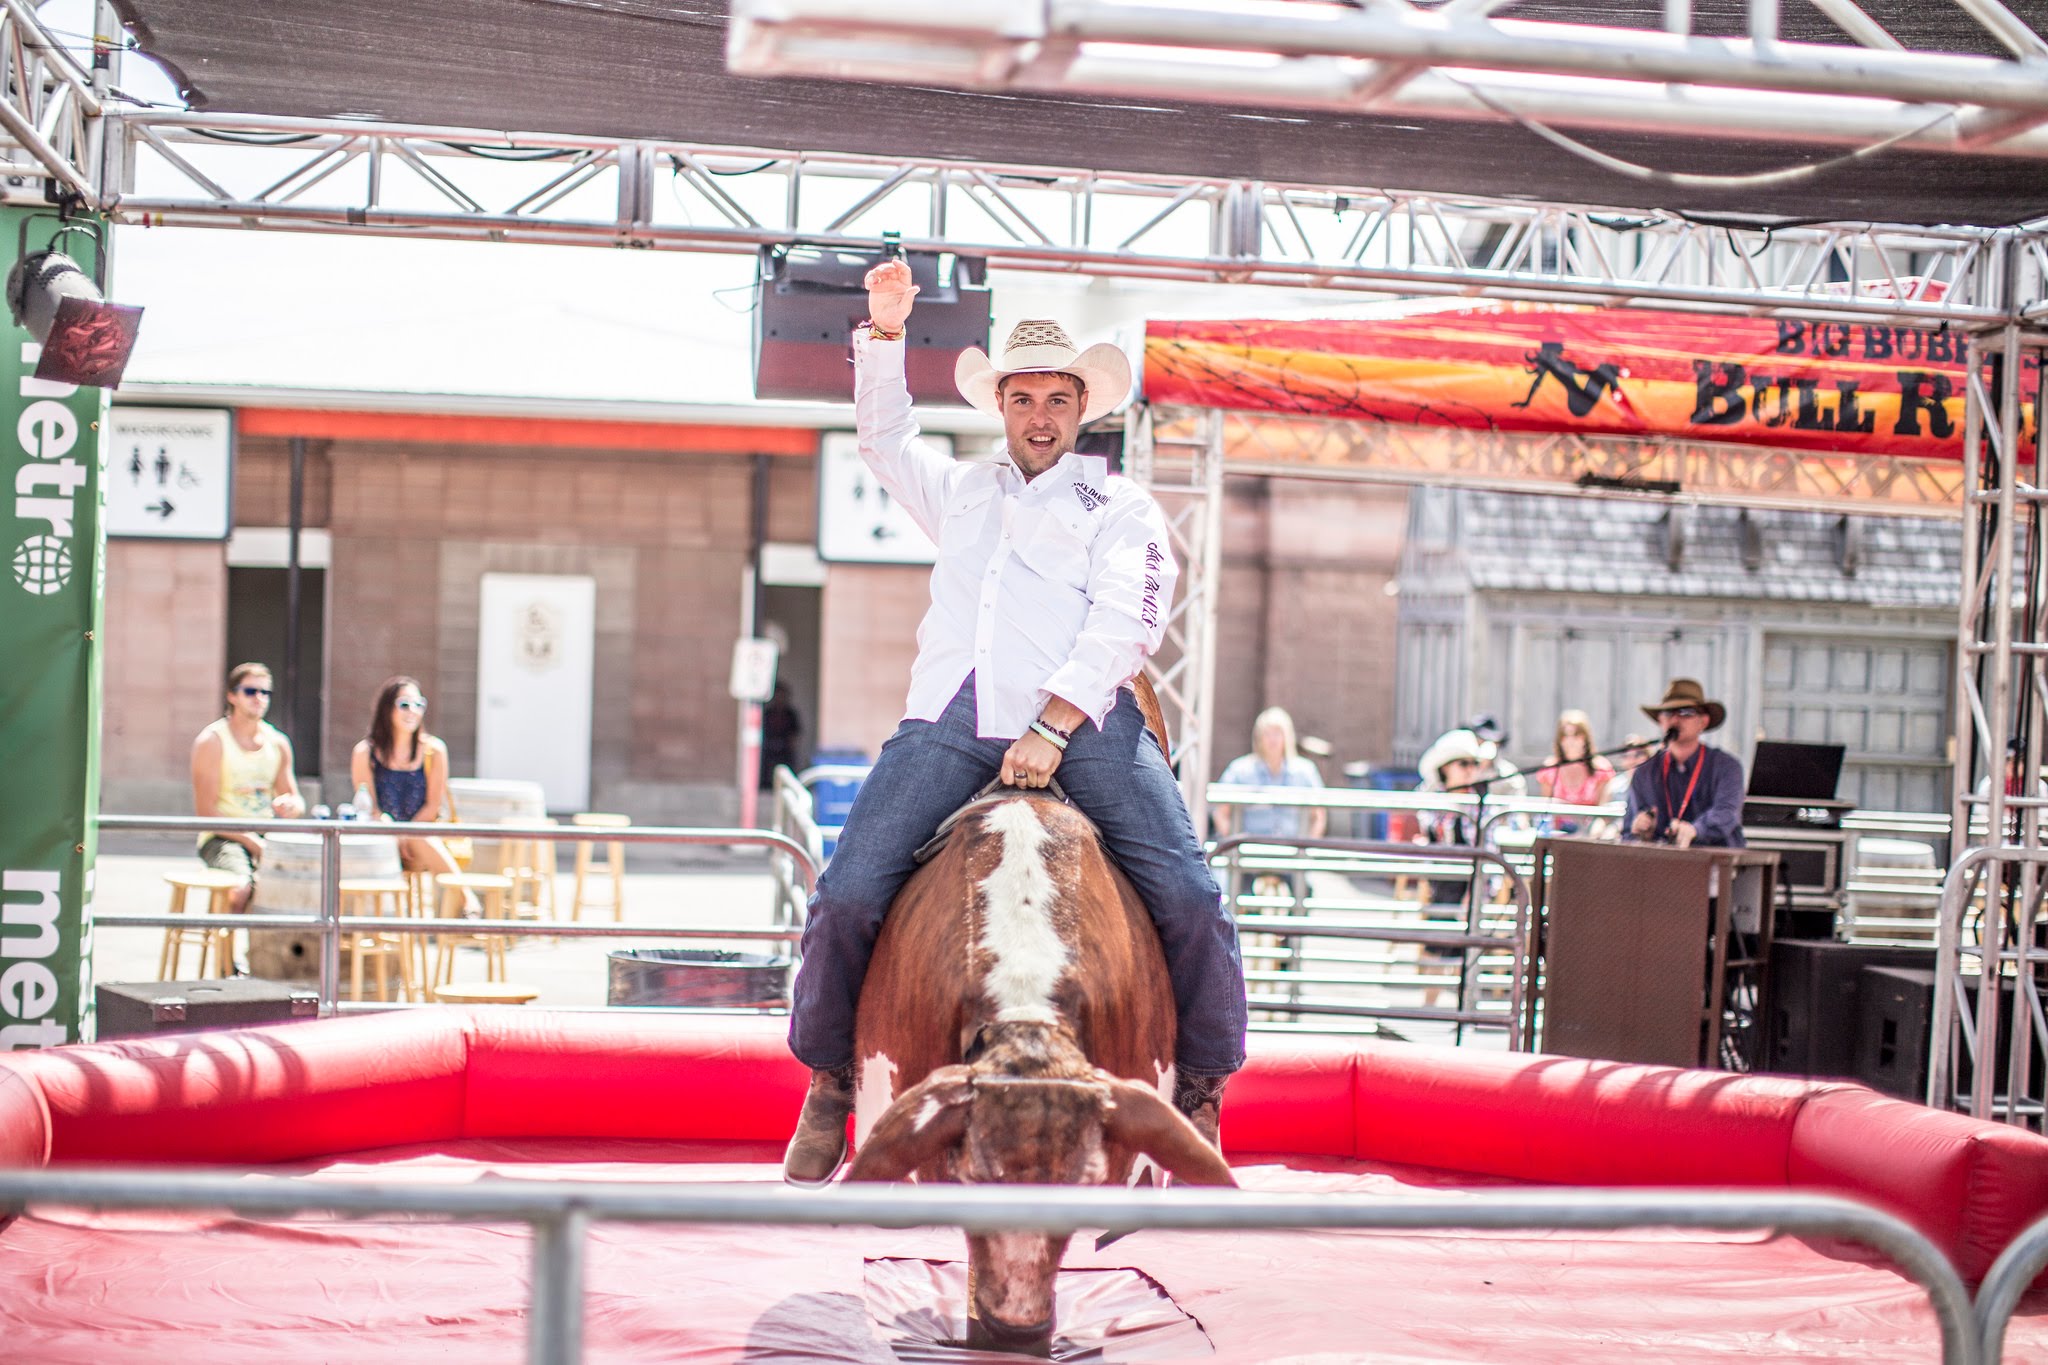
(782, 262, 1245, 1185)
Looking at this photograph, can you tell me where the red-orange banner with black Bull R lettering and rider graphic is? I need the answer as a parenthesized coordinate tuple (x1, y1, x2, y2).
(1145, 303, 2036, 458)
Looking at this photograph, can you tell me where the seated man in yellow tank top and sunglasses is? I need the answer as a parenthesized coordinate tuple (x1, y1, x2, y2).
(193, 663, 305, 915)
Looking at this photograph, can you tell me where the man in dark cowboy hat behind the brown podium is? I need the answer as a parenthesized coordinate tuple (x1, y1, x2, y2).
(1622, 677, 1745, 849)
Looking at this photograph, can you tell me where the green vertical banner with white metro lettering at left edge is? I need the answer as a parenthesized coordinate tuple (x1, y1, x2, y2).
(0, 209, 106, 1052)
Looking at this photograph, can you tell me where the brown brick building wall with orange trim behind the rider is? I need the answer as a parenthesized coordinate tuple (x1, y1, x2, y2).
(102, 397, 1407, 823)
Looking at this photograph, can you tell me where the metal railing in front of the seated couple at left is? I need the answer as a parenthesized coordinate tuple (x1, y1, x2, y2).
(92, 814, 817, 1015)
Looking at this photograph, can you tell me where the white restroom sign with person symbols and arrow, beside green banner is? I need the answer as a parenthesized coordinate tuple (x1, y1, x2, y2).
(106, 407, 233, 540)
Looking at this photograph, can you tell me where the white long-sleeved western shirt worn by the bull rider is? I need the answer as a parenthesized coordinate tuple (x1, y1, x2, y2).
(854, 329, 1180, 739)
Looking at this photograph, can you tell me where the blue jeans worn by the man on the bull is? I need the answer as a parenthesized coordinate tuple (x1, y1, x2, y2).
(788, 673, 1245, 1076)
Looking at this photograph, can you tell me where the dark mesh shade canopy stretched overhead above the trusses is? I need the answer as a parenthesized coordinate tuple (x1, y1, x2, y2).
(115, 0, 2048, 225)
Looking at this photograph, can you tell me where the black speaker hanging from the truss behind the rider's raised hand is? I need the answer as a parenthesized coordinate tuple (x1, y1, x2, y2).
(754, 246, 989, 405)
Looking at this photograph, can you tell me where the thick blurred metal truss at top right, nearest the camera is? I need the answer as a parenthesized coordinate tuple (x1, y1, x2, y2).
(727, 0, 2048, 158)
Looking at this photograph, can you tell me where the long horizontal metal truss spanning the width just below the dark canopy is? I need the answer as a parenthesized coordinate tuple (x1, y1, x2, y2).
(72, 111, 2023, 323)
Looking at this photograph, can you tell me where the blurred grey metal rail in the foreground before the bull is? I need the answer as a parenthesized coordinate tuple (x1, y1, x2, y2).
(0, 1166, 1982, 1365)
